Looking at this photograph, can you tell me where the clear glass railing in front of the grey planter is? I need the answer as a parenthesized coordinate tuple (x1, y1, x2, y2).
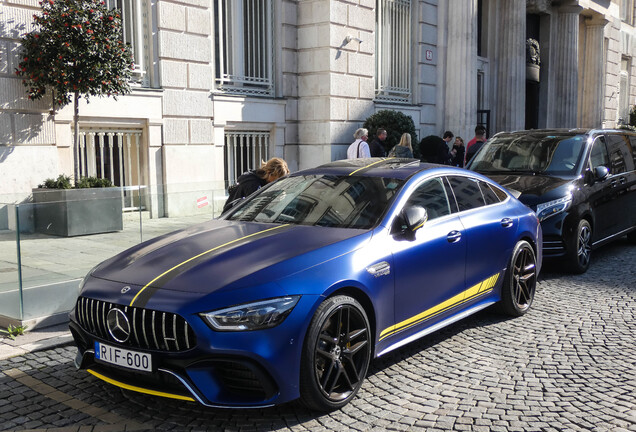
(0, 184, 225, 327)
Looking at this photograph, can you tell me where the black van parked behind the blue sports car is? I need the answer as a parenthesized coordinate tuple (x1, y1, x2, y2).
(467, 129, 636, 273)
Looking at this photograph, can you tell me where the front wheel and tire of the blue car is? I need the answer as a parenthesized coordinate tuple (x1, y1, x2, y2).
(300, 295, 371, 411)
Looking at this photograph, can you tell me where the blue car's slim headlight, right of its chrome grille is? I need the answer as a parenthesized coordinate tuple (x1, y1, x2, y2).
(200, 296, 300, 331)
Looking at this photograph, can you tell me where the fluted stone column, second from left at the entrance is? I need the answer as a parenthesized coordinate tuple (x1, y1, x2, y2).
(488, 0, 526, 136)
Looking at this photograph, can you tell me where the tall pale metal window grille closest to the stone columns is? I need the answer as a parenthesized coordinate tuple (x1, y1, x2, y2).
(375, 0, 412, 102)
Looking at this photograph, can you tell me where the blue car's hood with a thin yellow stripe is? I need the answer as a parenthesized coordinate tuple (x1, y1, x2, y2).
(91, 220, 370, 293)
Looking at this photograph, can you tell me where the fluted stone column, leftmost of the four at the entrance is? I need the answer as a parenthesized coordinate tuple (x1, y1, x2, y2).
(443, 0, 477, 139)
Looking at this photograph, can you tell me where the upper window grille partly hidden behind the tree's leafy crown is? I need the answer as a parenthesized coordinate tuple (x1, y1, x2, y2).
(106, 0, 149, 85)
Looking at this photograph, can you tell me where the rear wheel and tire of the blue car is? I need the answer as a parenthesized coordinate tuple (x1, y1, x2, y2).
(500, 240, 537, 317)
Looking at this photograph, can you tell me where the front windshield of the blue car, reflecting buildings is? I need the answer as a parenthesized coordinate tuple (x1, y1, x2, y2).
(228, 175, 404, 229)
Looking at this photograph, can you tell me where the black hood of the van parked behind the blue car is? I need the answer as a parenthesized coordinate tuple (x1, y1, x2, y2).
(485, 174, 573, 206)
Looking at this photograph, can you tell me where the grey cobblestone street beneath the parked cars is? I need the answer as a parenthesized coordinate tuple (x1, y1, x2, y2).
(0, 240, 636, 432)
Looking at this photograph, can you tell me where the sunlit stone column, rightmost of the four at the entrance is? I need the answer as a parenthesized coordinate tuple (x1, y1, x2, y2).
(579, 16, 607, 128)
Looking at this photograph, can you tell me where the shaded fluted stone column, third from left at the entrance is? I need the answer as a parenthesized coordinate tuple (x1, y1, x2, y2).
(550, 5, 580, 128)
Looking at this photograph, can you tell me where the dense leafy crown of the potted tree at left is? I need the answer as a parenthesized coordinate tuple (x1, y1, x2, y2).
(15, 0, 133, 110)
